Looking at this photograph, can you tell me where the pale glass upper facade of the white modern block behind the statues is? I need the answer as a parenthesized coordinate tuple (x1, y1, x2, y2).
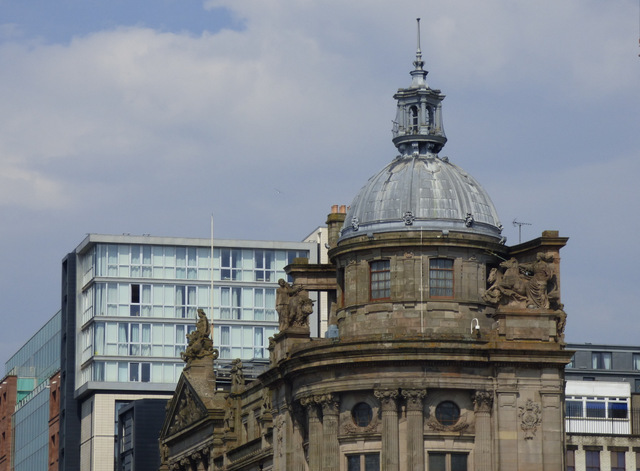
(76, 235, 317, 388)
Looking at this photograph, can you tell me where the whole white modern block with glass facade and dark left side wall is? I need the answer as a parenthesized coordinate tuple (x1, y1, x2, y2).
(59, 234, 318, 471)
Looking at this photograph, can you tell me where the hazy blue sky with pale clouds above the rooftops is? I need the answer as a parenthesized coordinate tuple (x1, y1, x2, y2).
(0, 0, 640, 369)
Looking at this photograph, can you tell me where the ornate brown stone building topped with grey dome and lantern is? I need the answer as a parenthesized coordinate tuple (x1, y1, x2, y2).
(160, 30, 571, 471)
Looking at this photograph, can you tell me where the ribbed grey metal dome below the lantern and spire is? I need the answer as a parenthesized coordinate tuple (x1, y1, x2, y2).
(339, 154, 502, 241)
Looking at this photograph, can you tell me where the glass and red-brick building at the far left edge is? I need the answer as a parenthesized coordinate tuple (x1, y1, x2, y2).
(0, 312, 61, 471)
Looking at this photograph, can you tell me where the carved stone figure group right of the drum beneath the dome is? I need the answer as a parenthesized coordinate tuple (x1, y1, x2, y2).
(482, 253, 557, 309)
